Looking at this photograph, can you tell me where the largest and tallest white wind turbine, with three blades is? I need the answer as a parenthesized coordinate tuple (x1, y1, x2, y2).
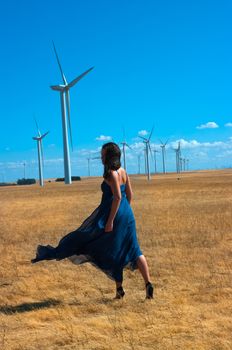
(51, 42, 94, 184)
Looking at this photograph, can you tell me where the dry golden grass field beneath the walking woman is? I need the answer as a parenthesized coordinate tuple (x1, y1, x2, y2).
(0, 170, 232, 350)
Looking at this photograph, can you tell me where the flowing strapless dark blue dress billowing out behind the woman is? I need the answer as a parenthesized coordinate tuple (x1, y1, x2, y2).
(31, 174, 142, 282)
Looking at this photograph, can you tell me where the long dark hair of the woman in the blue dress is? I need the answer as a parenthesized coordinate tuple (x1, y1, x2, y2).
(102, 142, 121, 179)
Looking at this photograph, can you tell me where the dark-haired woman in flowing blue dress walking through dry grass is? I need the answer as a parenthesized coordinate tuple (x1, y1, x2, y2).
(31, 142, 153, 299)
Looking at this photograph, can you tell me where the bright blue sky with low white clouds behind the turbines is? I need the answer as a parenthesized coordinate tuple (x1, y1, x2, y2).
(0, 0, 232, 181)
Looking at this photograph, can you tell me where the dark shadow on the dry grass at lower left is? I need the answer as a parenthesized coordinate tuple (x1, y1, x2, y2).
(0, 299, 61, 315)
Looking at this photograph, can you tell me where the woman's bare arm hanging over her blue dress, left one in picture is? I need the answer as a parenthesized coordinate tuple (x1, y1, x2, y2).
(105, 171, 122, 232)
